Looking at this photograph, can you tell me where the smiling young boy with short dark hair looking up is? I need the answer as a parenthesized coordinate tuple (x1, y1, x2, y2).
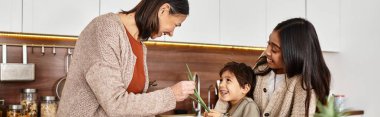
(205, 62, 260, 117)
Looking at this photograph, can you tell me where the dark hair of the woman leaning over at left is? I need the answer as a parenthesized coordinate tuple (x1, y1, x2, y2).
(120, 0, 189, 41)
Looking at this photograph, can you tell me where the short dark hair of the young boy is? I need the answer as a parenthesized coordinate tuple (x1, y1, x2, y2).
(219, 61, 256, 99)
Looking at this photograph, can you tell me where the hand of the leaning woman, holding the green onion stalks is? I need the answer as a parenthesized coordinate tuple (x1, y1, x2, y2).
(170, 81, 195, 102)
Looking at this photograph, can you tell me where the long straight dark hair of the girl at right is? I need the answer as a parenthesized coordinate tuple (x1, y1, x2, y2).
(274, 18, 331, 115)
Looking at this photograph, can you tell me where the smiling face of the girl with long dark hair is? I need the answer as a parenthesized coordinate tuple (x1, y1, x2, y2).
(264, 31, 284, 72)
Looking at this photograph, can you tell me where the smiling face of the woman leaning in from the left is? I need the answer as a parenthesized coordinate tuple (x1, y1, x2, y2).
(151, 3, 187, 39)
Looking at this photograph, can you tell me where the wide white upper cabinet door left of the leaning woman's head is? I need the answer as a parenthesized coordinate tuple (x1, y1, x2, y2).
(23, 0, 100, 35)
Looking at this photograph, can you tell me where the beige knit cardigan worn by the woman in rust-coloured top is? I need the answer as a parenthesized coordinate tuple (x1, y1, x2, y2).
(57, 13, 176, 117)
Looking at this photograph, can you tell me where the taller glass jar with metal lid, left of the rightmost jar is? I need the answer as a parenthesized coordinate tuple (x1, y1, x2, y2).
(20, 88, 38, 117)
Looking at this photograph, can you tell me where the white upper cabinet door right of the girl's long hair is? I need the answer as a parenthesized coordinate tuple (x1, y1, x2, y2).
(306, 0, 341, 52)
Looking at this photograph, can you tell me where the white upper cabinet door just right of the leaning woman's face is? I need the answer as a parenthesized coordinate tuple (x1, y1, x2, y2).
(158, 0, 220, 44)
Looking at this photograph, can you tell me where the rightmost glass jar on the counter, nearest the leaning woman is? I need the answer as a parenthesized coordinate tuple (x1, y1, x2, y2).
(40, 96, 58, 117)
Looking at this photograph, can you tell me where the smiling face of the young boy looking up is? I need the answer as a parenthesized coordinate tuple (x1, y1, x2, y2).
(219, 71, 250, 104)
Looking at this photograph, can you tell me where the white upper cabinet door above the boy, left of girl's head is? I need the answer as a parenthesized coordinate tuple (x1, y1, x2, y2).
(220, 0, 267, 47)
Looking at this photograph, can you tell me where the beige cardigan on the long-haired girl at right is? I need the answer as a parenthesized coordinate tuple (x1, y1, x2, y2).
(215, 68, 316, 117)
